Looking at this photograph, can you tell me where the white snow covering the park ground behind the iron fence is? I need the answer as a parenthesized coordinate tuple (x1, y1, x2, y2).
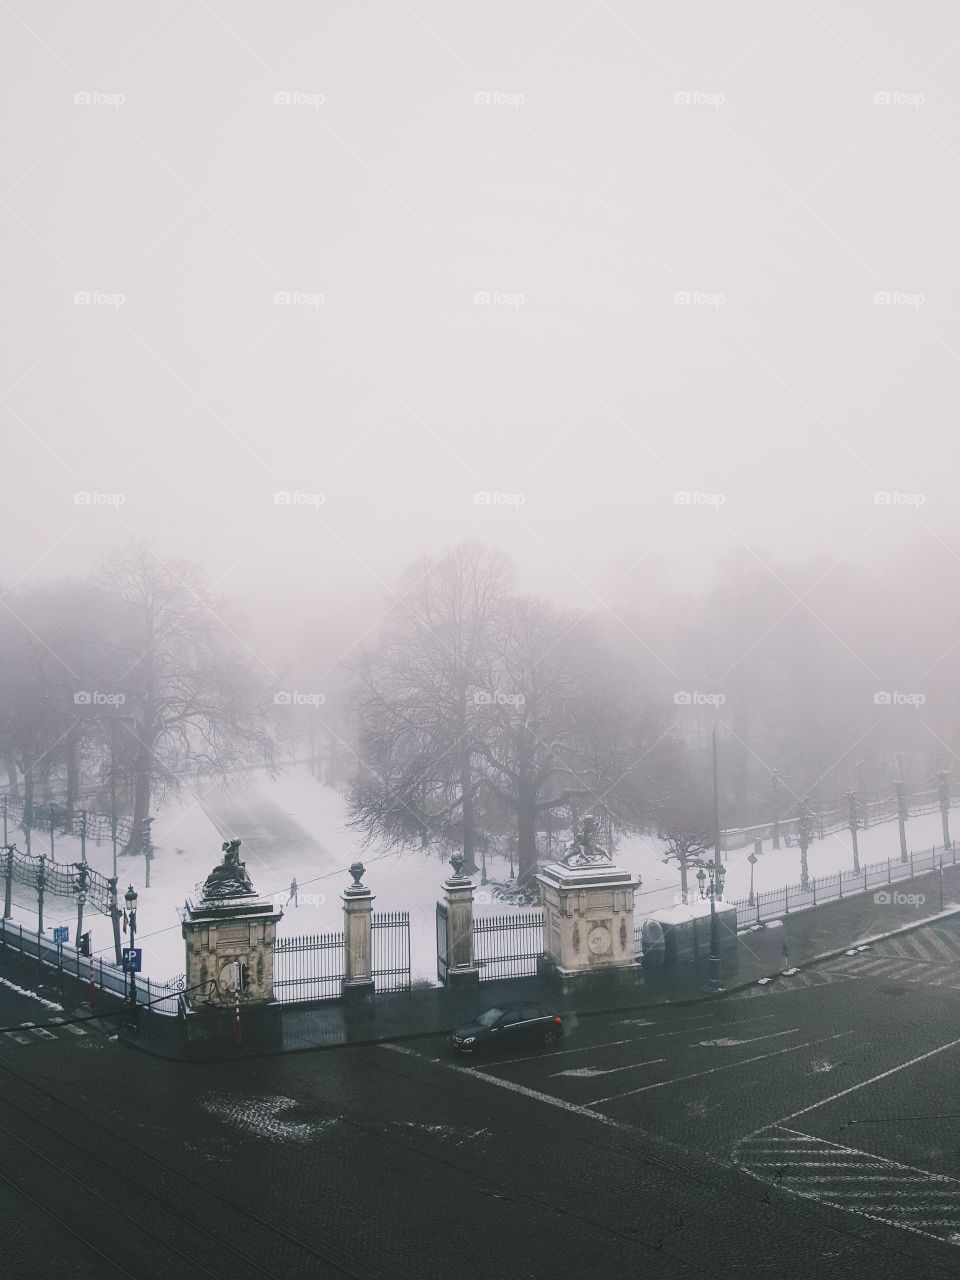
(5, 765, 957, 980)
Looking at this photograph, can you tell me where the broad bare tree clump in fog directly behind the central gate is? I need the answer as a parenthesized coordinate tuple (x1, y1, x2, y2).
(352, 543, 675, 881)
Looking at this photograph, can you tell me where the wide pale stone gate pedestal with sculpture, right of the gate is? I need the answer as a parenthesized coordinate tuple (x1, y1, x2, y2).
(536, 817, 640, 995)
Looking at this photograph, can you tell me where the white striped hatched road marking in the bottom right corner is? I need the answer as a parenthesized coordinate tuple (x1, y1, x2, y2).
(733, 1125, 960, 1243)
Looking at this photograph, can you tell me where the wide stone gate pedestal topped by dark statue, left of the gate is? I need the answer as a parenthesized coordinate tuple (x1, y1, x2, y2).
(180, 840, 283, 1042)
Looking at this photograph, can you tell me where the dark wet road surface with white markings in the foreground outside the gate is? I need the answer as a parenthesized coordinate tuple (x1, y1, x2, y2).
(0, 922, 960, 1280)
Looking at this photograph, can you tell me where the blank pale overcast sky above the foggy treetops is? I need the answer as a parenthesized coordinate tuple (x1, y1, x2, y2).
(0, 0, 960, 634)
